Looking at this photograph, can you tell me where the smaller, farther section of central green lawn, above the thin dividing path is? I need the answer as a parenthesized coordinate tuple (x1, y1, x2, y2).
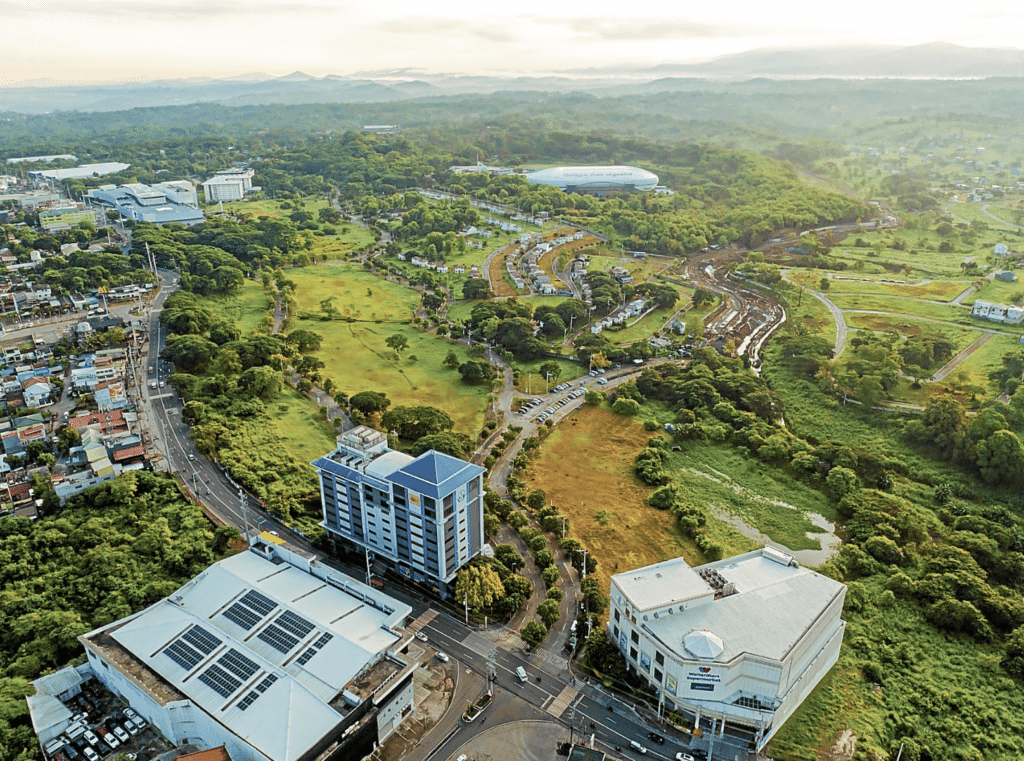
(285, 262, 420, 321)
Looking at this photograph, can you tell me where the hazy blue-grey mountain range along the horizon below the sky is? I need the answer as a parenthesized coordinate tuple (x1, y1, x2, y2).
(6, 43, 1024, 114)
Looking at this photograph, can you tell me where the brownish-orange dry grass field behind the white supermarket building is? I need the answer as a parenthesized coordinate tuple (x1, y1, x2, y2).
(527, 408, 751, 590)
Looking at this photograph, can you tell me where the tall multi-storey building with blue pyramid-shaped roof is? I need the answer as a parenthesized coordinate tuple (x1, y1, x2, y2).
(312, 426, 484, 596)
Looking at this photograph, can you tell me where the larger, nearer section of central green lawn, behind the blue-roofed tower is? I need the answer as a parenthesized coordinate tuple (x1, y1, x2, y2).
(292, 320, 490, 435)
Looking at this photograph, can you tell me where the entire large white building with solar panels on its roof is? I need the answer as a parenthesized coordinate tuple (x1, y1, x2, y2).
(72, 534, 418, 761)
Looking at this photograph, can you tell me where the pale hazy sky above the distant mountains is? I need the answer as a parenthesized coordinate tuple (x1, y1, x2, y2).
(0, 0, 1024, 85)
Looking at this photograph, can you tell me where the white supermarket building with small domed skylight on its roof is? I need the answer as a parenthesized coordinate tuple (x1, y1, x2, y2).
(608, 547, 846, 751)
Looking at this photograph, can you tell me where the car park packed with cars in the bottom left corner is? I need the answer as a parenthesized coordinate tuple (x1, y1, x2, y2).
(44, 679, 173, 761)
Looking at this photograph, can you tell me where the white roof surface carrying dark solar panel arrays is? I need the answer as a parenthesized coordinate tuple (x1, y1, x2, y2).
(96, 552, 408, 761)
